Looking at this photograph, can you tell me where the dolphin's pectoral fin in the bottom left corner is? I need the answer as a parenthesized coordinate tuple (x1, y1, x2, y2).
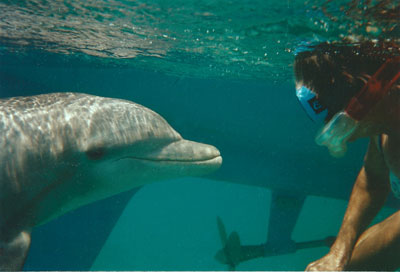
(0, 231, 31, 271)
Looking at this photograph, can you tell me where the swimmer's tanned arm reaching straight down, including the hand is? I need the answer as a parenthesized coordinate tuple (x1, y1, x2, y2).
(306, 138, 390, 271)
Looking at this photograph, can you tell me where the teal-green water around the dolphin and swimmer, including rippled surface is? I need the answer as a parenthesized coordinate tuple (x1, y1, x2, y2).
(0, 0, 398, 270)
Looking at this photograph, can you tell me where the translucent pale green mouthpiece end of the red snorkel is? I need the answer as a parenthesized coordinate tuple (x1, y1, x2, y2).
(315, 111, 358, 158)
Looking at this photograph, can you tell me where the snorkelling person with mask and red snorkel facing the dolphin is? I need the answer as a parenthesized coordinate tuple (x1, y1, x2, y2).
(294, 42, 400, 271)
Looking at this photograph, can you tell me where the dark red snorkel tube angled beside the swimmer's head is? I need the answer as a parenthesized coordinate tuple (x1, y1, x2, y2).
(345, 56, 400, 121)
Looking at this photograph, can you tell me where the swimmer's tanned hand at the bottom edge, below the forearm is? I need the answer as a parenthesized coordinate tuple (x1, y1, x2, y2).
(306, 251, 349, 271)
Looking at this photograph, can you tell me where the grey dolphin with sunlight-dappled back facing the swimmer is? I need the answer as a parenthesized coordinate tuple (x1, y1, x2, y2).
(0, 93, 222, 270)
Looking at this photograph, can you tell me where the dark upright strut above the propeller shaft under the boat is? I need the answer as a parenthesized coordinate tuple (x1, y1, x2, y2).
(264, 191, 306, 257)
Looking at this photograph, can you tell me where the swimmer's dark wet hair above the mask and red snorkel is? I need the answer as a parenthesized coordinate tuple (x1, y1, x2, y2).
(294, 41, 400, 121)
